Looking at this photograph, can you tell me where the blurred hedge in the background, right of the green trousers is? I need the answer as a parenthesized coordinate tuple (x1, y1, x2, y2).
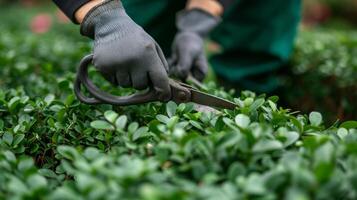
(282, 29, 357, 122)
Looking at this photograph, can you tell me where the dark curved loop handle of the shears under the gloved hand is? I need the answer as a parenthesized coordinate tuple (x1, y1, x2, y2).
(74, 54, 158, 106)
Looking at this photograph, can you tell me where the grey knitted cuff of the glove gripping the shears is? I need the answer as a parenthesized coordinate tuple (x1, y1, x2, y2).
(80, 0, 125, 39)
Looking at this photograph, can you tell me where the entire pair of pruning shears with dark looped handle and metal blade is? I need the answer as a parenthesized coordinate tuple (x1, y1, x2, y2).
(74, 54, 237, 110)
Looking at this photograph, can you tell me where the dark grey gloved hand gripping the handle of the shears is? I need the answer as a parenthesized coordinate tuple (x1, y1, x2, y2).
(81, 0, 171, 101)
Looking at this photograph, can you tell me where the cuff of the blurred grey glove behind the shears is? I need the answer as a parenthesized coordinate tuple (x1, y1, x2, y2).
(176, 8, 221, 37)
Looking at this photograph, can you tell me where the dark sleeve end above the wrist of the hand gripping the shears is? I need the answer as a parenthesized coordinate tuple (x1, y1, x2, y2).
(53, 0, 90, 24)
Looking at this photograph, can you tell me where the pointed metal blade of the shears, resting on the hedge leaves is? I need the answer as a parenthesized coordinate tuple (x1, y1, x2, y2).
(191, 90, 237, 110)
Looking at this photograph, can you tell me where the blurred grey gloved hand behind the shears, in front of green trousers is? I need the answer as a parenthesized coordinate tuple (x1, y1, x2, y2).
(169, 9, 220, 81)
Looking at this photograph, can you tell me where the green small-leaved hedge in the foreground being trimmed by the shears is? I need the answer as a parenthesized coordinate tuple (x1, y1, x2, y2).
(0, 7, 357, 200)
